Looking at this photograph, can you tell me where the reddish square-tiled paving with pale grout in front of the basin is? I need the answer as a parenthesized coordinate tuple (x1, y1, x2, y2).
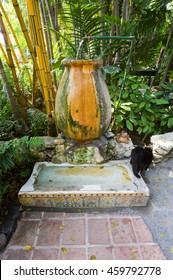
(1, 212, 166, 260)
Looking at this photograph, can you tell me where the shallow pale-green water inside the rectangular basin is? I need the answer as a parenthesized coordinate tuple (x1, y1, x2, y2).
(34, 165, 131, 190)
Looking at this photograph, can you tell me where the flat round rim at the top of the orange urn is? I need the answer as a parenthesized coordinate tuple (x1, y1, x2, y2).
(61, 58, 103, 66)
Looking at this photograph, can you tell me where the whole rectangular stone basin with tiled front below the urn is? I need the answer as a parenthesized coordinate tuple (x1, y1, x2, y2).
(18, 160, 149, 208)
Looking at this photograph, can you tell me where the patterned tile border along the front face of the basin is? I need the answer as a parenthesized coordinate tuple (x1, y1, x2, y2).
(19, 194, 148, 208)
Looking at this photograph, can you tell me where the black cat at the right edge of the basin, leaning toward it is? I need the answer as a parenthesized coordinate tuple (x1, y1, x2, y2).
(130, 146, 153, 178)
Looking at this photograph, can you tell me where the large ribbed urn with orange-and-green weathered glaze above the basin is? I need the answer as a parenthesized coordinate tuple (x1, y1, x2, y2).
(55, 59, 111, 141)
